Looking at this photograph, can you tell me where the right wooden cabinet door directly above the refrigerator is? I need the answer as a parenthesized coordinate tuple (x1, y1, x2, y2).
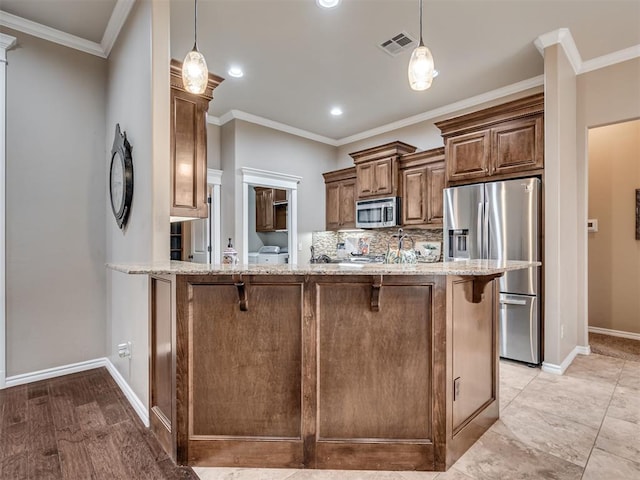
(491, 116, 544, 174)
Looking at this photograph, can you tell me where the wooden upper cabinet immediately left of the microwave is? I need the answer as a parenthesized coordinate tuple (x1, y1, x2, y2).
(322, 167, 356, 230)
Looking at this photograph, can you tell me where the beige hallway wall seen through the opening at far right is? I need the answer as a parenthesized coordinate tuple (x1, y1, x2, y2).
(587, 119, 640, 340)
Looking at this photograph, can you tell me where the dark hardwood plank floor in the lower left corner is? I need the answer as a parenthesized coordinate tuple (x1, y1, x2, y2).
(0, 368, 198, 480)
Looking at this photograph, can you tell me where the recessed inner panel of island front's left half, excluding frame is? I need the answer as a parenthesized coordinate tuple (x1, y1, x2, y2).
(189, 284, 302, 439)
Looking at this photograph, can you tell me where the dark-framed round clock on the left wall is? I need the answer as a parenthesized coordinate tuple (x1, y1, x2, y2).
(109, 124, 133, 228)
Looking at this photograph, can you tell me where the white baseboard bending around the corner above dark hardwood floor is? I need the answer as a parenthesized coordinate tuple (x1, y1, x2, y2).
(5, 358, 149, 427)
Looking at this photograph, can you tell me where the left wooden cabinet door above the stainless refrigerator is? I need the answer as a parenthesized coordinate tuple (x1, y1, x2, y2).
(445, 130, 491, 181)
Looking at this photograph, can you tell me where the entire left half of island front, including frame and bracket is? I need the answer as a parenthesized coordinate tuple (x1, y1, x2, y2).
(176, 275, 304, 467)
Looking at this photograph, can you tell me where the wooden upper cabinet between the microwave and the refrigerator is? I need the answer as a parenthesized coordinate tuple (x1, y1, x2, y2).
(400, 148, 445, 227)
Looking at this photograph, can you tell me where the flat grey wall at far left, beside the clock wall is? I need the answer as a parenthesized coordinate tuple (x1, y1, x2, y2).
(2, 28, 106, 376)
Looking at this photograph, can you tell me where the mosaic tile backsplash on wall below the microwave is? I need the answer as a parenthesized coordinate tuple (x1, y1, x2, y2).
(311, 228, 442, 261)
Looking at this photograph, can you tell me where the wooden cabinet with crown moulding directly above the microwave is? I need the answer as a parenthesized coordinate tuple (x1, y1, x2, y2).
(349, 142, 416, 200)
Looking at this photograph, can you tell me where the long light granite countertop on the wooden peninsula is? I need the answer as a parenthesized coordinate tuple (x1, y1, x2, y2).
(107, 260, 542, 276)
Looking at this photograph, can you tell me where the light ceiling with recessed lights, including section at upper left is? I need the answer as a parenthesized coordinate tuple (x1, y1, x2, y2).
(1, 0, 640, 141)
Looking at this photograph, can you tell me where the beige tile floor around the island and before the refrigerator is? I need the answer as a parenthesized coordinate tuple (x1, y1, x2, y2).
(194, 355, 640, 480)
